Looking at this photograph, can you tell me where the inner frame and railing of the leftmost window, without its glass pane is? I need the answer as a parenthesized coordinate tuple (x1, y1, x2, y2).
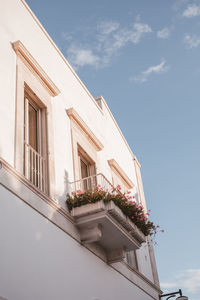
(23, 85, 49, 194)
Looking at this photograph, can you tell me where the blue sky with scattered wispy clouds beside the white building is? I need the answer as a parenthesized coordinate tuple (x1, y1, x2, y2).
(27, 0, 200, 300)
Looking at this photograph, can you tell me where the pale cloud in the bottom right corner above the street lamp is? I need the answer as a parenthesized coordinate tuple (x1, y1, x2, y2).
(160, 269, 200, 299)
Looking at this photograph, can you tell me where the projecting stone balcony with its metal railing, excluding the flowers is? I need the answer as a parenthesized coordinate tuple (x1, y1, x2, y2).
(71, 174, 146, 263)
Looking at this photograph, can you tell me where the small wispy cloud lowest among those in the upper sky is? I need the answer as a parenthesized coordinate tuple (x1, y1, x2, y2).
(131, 59, 169, 83)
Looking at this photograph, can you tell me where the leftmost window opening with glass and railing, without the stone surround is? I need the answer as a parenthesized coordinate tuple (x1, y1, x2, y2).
(24, 89, 48, 192)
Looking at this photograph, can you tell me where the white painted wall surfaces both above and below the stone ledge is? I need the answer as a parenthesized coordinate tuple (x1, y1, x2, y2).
(0, 0, 159, 292)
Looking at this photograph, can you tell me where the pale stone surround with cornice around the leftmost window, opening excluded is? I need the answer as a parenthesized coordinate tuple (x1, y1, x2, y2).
(12, 41, 60, 200)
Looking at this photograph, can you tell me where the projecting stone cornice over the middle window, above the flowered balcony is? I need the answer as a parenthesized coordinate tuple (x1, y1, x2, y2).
(66, 107, 103, 151)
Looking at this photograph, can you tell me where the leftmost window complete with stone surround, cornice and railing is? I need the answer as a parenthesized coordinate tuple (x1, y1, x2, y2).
(12, 41, 60, 199)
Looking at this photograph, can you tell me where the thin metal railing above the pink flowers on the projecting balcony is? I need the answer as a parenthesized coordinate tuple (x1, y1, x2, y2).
(70, 173, 114, 192)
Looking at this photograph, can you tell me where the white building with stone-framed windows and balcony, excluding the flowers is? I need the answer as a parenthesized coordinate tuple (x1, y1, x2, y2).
(0, 0, 161, 300)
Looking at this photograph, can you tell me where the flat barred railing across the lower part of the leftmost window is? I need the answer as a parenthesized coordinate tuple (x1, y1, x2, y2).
(24, 143, 47, 193)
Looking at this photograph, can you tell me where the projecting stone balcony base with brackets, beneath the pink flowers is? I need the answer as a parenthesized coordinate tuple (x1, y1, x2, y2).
(71, 200, 146, 260)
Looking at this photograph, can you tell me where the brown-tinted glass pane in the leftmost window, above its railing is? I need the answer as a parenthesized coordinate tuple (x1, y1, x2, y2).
(28, 103, 38, 151)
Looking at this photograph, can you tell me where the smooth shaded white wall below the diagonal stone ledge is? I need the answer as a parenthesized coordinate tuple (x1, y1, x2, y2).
(0, 186, 152, 300)
